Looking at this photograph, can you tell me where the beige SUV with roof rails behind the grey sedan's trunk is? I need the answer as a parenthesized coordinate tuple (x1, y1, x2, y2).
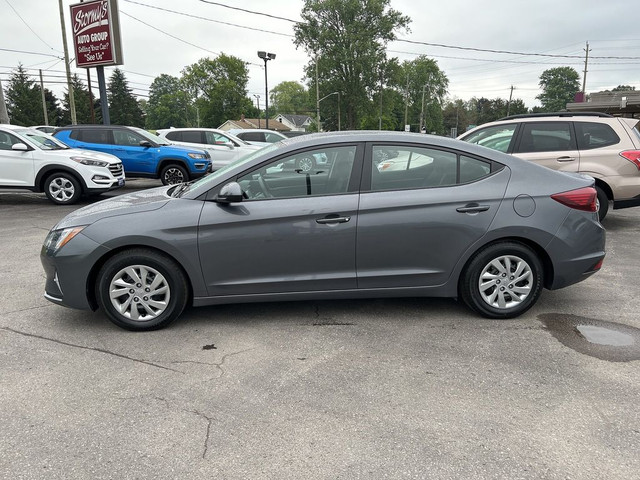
(458, 112, 640, 220)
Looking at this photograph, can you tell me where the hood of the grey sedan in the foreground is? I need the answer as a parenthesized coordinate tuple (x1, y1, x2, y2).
(54, 185, 175, 229)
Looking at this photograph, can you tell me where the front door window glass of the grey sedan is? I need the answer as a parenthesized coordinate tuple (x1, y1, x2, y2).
(237, 145, 356, 200)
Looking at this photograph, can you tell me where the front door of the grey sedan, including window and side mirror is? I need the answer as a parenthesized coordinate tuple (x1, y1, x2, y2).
(198, 143, 363, 295)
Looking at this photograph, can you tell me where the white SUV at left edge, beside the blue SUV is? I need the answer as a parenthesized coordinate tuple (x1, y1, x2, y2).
(0, 125, 125, 205)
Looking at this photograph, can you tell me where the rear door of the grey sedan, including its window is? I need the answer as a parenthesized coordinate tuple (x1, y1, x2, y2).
(356, 144, 509, 288)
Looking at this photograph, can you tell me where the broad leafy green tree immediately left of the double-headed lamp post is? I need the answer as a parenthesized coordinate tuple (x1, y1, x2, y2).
(182, 54, 255, 128)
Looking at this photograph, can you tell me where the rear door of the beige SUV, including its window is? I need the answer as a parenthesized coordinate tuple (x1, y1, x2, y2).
(513, 121, 580, 172)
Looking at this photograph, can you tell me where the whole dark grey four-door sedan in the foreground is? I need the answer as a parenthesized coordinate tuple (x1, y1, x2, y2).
(41, 132, 605, 330)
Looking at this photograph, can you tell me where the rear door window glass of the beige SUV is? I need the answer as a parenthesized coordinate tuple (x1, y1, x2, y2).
(517, 122, 576, 153)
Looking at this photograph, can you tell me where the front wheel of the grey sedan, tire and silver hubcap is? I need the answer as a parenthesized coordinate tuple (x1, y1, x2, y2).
(96, 249, 189, 331)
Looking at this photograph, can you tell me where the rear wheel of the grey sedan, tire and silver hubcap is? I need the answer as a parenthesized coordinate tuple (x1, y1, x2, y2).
(459, 241, 544, 319)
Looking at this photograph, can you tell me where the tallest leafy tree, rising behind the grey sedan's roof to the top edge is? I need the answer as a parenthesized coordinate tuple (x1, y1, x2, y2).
(294, 0, 410, 129)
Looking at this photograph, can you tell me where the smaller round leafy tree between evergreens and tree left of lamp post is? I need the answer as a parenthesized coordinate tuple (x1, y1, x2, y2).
(146, 74, 196, 130)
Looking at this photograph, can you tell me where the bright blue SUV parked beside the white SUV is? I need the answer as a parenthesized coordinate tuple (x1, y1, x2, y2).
(54, 125, 211, 185)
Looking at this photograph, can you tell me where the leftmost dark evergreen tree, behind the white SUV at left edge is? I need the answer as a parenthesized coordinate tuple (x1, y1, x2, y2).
(5, 64, 44, 126)
